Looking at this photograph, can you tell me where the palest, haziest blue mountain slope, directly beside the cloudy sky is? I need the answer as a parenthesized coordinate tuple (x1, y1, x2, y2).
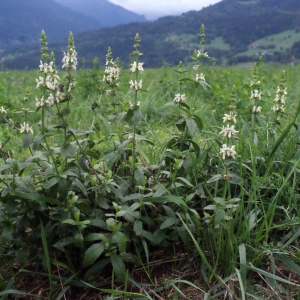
(55, 0, 147, 27)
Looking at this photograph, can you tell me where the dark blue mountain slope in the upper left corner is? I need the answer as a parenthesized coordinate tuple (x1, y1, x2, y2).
(0, 0, 102, 51)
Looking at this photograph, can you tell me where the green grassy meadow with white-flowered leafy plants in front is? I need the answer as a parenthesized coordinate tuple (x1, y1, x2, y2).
(0, 27, 300, 300)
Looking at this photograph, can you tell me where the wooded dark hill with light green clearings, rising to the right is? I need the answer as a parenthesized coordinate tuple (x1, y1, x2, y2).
(3, 0, 300, 68)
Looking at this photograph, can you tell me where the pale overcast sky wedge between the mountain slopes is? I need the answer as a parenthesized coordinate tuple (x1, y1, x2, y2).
(109, 0, 221, 20)
